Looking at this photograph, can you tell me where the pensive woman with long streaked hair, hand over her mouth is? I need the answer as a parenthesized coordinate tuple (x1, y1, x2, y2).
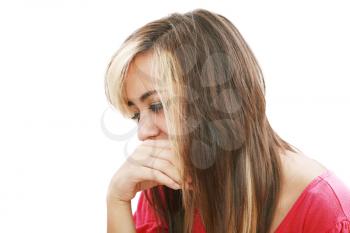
(106, 9, 350, 233)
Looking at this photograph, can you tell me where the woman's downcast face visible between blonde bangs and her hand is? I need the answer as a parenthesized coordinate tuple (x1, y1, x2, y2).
(125, 52, 168, 141)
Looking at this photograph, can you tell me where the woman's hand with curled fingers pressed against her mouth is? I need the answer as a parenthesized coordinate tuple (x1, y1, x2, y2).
(107, 140, 181, 202)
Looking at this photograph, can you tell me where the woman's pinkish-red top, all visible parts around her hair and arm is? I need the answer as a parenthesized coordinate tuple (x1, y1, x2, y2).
(133, 169, 350, 233)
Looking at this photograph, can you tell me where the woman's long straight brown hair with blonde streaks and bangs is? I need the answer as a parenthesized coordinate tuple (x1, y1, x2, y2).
(105, 9, 298, 233)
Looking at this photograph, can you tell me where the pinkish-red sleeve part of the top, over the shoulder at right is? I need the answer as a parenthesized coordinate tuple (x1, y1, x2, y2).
(276, 167, 350, 233)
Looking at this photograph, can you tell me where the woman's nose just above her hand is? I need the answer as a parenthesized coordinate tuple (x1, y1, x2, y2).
(137, 113, 160, 141)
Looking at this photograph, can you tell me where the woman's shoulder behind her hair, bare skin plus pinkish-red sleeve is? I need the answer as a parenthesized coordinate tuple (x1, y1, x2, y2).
(276, 152, 350, 233)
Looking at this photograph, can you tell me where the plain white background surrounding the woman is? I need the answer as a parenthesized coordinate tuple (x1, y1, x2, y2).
(0, 0, 350, 233)
